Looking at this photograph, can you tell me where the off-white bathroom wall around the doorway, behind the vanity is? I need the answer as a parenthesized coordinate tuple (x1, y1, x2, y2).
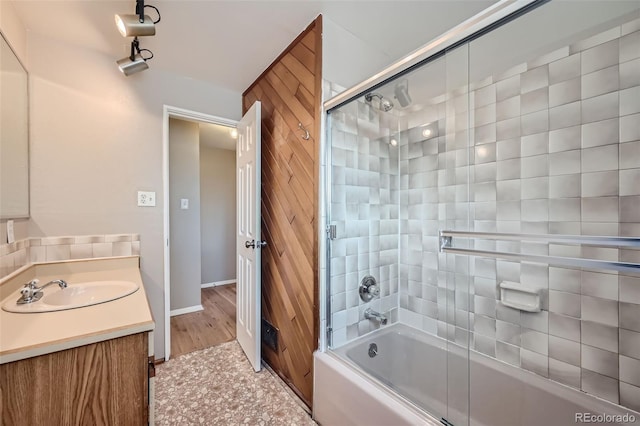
(24, 33, 241, 357)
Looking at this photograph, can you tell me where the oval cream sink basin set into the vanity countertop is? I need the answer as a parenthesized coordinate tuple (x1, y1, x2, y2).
(2, 281, 139, 313)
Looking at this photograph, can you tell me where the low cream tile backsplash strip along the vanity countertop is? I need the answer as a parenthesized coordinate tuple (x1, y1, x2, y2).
(0, 234, 140, 277)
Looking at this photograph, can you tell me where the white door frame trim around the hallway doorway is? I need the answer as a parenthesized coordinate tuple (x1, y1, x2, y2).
(162, 105, 238, 361)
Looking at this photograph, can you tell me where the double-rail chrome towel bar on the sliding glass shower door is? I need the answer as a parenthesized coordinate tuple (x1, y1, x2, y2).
(440, 231, 640, 273)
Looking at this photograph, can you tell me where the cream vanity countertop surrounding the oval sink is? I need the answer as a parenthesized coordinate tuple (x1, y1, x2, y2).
(0, 256, 155, 364)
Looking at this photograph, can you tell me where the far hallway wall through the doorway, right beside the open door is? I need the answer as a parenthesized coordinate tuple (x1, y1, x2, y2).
(200, 144, 236, 284)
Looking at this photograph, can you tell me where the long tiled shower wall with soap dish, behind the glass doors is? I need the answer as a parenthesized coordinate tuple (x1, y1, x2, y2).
(399, 20, 640, 410)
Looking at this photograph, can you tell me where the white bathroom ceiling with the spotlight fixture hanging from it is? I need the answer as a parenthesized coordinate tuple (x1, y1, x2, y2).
(12, 0, 495, 92)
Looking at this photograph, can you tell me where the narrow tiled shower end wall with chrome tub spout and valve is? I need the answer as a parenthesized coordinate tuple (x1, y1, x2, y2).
(329, 92, 399, 347)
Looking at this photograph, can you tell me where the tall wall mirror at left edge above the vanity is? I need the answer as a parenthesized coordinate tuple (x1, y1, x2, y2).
(0, 33, 29, 219)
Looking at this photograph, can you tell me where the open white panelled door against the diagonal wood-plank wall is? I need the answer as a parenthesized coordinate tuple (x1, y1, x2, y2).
(236, 102, 266, 371)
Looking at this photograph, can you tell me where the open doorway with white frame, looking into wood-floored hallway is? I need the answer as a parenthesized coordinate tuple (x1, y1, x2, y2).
(163, 106, 237, 360)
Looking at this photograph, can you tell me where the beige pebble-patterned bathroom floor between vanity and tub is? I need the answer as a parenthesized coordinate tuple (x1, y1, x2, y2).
(155, 341, 316, 426)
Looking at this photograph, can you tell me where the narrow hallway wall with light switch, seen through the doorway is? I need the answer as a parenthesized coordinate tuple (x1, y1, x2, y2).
(169, 119, 202, 311)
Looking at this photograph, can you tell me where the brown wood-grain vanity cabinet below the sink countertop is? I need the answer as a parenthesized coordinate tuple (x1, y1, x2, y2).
(0, 332, 152, 426)
